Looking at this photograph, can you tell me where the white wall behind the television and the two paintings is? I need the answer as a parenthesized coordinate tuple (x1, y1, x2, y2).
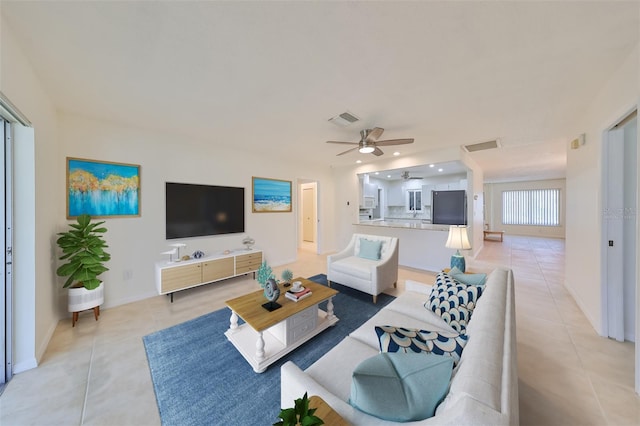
(56, 113, 333, 312)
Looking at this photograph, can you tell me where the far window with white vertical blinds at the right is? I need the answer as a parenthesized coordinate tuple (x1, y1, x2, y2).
(502, 189, 560, 226)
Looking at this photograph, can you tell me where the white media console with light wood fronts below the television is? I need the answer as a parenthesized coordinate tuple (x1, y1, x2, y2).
(156, 250, 262, 303)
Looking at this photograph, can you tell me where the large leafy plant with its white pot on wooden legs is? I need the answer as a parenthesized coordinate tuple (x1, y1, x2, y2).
(56, 214, 111, 326)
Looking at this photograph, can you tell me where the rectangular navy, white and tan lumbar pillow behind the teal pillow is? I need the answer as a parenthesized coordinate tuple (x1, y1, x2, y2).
(375, 325, 468, 366)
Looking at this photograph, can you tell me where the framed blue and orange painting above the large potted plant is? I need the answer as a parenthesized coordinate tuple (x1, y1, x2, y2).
(67, 157, 140, 219)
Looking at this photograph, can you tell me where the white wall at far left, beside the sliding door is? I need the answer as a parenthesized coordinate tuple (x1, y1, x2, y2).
(0, 18, 64, 372)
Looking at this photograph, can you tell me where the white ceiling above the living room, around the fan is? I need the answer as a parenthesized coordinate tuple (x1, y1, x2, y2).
(0, 0, 640, 181)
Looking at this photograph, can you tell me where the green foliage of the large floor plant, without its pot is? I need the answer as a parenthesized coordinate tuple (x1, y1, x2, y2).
(56, 214, 111, 290)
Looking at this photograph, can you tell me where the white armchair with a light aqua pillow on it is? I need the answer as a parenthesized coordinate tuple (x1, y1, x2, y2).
(327, 234, 398, 303)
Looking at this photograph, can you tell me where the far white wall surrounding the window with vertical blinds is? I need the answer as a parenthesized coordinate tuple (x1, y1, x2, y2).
(484, 179, 567, 238)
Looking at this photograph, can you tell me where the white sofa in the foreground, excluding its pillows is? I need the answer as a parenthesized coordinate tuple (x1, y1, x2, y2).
(280, 269, 519, 426)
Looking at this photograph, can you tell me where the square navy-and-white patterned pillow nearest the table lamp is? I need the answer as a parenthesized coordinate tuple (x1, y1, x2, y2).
(424, 272, 482, 333)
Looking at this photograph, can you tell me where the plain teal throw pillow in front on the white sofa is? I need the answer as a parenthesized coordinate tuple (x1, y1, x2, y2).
(349, 353, 452, 422)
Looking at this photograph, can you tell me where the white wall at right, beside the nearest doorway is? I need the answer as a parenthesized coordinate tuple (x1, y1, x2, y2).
(566, 40, 640, 334)
